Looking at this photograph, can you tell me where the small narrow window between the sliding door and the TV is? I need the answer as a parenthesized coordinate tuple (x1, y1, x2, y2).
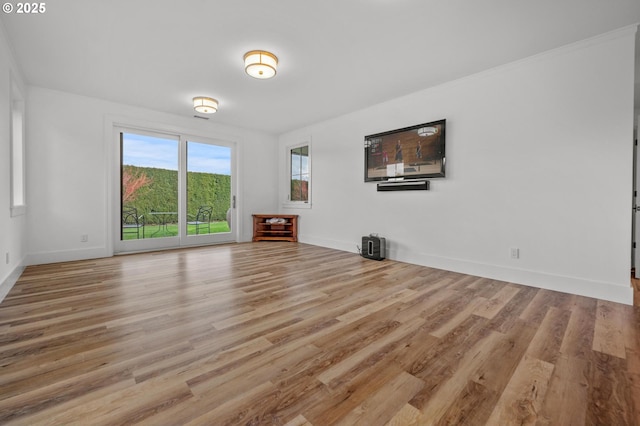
(287, 143, 311, 207)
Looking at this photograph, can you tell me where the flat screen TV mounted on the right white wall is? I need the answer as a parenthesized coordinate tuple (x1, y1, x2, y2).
(364, 120, 446, 182)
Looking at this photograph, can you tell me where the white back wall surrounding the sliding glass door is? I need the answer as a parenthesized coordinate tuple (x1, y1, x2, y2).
(27, 87, 277, 264)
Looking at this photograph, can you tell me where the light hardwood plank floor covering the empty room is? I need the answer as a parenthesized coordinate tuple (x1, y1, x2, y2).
(0, 242, 640, 426)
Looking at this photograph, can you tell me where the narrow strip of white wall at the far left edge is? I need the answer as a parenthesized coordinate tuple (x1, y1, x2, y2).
(0, 23, 28, 301)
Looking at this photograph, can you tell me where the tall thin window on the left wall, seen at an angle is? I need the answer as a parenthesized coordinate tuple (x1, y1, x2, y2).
(11, 82, 26, 216)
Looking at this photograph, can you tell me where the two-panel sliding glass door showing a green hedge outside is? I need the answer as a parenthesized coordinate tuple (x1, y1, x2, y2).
(114, 129, 236, 253)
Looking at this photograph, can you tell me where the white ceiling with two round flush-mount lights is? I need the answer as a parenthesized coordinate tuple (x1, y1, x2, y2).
(0, 0, 640, 134)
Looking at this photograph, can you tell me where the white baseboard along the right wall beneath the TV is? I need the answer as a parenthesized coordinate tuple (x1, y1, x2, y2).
(300, 233, 633, 305)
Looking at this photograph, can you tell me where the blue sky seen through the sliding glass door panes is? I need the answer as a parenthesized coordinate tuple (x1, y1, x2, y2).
(122, 133, 231, 175)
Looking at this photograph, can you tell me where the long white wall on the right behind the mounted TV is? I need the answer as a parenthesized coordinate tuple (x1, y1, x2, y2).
(280, 27, 635, 303)
